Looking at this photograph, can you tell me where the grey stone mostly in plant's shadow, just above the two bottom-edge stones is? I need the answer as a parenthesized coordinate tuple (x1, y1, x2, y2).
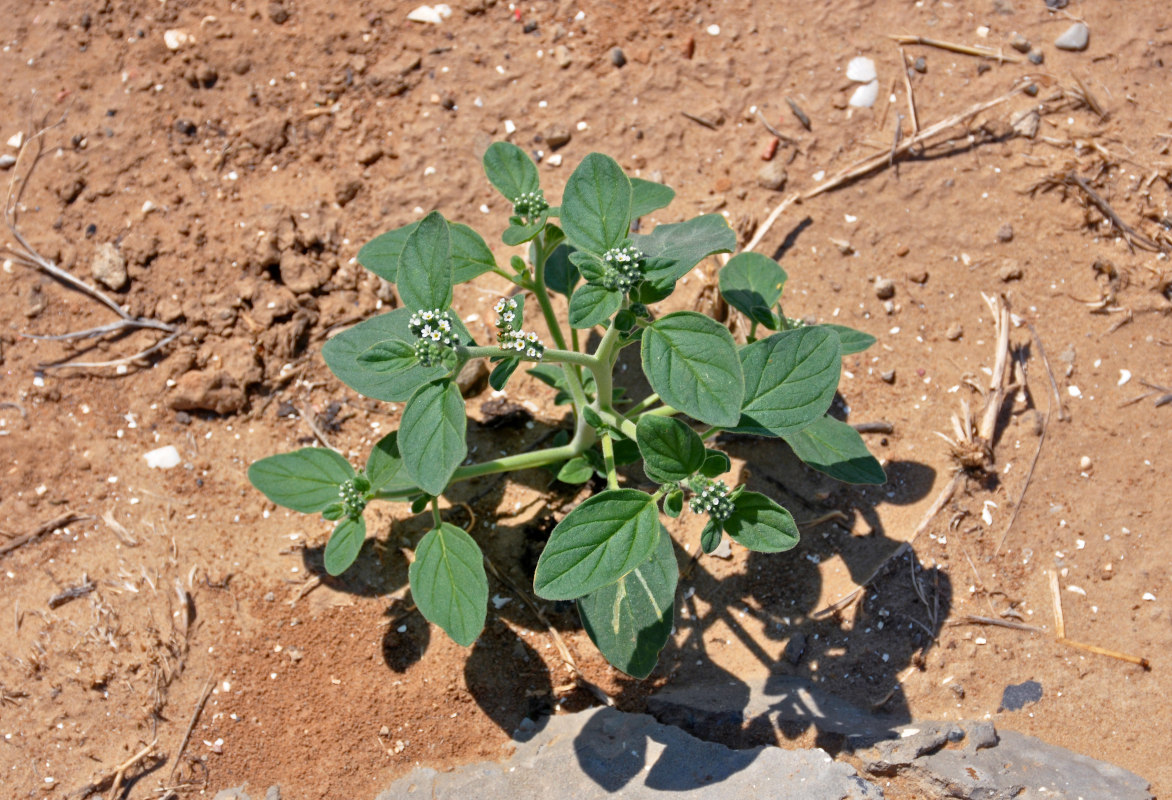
(647, 675, 897, 747)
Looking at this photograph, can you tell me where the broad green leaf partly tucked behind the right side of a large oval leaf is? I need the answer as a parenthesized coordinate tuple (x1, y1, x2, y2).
(731, 327, 843, 436)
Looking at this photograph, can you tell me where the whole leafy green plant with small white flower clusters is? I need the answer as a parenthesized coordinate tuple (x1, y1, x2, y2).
(248, 143, 886, 677)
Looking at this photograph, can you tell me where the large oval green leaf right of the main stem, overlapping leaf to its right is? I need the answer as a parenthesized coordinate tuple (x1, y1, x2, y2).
(641, 312, 740, 428)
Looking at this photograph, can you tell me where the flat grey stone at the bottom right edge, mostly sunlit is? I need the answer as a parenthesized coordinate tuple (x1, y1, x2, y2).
(866, 723, 1153, 800)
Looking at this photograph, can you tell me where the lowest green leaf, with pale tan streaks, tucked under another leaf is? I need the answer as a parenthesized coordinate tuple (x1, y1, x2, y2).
(578, 526, 680, 678)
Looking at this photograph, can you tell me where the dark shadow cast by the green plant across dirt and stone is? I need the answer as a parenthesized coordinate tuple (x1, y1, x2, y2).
(297, 351, 953, 791)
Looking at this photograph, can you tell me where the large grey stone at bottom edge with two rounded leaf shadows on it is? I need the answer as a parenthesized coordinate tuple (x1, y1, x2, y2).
(377, 707, 883, 800)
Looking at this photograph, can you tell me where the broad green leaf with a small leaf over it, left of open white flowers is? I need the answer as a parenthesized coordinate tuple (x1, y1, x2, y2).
(321, 308, 473, 403)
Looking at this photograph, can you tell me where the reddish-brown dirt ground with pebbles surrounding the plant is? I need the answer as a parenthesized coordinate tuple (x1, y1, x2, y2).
(0, 0, 1172, 798)
